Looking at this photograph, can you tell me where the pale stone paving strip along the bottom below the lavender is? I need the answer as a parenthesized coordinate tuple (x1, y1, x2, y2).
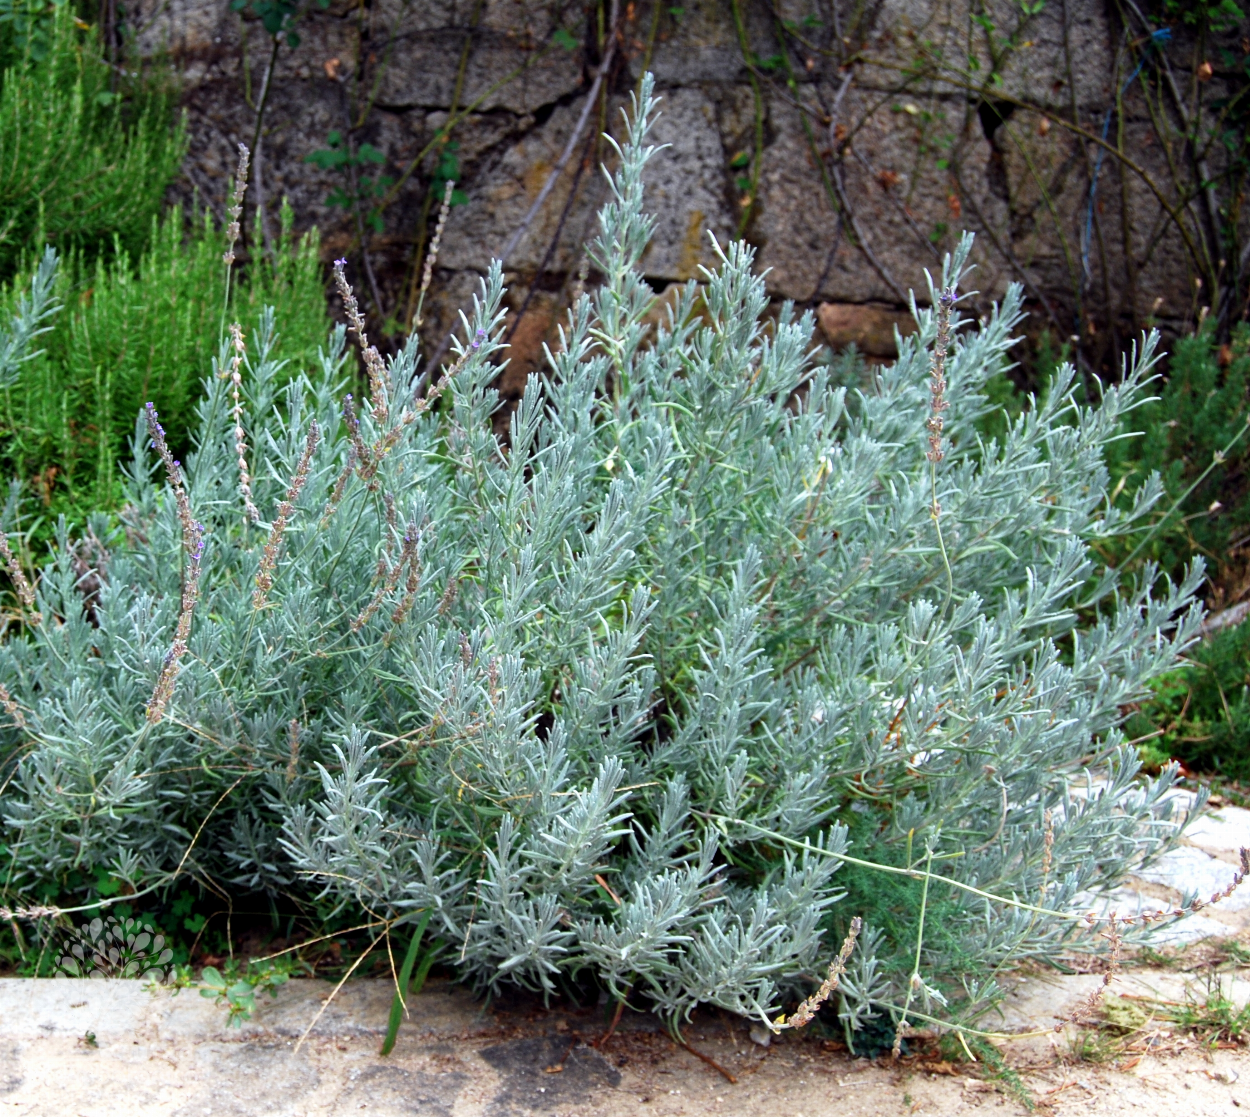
(0, 973, 1250, 1117)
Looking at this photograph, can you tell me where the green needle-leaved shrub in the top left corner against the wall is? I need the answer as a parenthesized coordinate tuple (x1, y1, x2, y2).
(0, 0, 186, 268)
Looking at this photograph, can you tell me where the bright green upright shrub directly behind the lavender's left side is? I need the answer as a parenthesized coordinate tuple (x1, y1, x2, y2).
(0, 206, 328, 535)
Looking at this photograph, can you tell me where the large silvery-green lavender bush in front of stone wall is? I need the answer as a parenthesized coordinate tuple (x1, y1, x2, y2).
(0, 80, 1200, 1028)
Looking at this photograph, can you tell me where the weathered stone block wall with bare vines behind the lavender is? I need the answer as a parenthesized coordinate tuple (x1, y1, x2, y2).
(138, 0, 1250, 386)
